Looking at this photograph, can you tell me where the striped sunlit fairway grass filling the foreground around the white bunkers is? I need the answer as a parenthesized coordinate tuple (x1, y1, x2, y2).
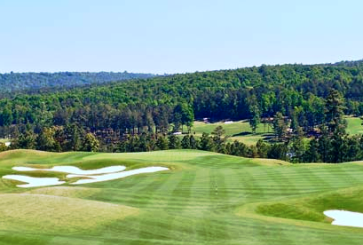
(0, 150, 363, 245)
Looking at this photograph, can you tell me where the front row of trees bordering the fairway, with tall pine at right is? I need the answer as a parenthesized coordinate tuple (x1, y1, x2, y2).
(0, 89, 363, 163)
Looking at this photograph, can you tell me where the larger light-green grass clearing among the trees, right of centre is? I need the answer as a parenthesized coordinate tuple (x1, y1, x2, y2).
(192, 120, 273, 145)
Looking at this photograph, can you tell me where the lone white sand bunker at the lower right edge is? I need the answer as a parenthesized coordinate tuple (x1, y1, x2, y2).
(324, 210, 363, 228)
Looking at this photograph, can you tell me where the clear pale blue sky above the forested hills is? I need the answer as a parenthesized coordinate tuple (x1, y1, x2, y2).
(0, 0, 363, 74)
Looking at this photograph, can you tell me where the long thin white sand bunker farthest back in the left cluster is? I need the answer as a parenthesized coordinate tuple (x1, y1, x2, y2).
(13, 166, 126, 175)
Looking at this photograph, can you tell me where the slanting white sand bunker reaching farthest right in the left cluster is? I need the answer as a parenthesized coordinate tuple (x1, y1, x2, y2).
(67, 167, 169, 185)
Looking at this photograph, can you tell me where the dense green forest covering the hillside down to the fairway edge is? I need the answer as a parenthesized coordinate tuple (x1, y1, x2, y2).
(0, 61, 363, 162)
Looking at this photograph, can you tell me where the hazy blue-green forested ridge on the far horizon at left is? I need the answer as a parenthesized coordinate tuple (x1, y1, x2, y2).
(0, 71, 154, 96)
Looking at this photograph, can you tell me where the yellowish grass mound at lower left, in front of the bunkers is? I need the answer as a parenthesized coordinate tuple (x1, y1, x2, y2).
(0, 194, 138, 233)
